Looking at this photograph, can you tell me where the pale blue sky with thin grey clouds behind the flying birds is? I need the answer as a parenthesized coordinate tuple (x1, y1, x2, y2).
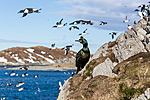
(0, 0, 148, 54)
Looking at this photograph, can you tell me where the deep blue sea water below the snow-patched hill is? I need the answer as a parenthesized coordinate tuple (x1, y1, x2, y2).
(0, 68, 73, 100)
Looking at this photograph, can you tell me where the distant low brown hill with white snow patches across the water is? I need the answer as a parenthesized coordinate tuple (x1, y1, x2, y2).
(0, 46, 76, 65)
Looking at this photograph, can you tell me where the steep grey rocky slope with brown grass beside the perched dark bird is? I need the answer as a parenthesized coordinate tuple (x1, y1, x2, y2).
(58, 17, 150, 100)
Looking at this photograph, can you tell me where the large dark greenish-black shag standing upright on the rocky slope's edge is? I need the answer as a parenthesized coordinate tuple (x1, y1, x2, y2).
(75, 36, 90, 74)
